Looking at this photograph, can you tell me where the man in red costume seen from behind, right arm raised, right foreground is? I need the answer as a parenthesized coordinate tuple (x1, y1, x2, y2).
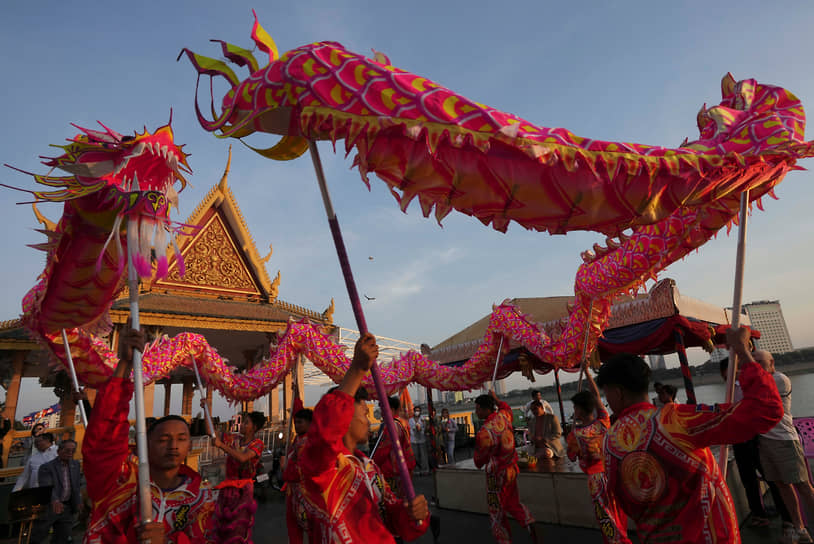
(597, 328, 783, 544)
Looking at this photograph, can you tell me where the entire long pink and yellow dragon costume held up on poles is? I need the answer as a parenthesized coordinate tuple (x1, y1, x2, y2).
(7, 13, 814, 400)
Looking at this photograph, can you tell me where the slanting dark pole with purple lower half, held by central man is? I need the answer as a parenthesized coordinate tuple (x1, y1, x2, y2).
(308, 140, 415, 501)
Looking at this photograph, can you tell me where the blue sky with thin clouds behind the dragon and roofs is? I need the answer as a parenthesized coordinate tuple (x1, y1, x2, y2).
(0, 0, 814, 416)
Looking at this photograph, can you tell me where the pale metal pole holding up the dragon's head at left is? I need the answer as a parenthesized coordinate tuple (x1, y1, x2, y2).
(127, 219, 153, 523)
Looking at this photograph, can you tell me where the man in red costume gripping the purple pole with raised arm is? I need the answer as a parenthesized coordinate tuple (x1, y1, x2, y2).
(299, 333, 429, 544)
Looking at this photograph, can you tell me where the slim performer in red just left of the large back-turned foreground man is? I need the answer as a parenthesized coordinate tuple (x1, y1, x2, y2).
(566, 364, 630, 544)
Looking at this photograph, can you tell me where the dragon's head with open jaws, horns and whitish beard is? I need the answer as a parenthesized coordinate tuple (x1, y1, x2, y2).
(6, 119, 190, 278)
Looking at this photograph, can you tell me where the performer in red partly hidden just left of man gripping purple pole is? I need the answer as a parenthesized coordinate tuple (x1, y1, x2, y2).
(283, 408, 314, 544)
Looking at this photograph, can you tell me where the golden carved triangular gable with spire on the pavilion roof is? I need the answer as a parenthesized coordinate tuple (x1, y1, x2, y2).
(153, 147, 280, 301)
